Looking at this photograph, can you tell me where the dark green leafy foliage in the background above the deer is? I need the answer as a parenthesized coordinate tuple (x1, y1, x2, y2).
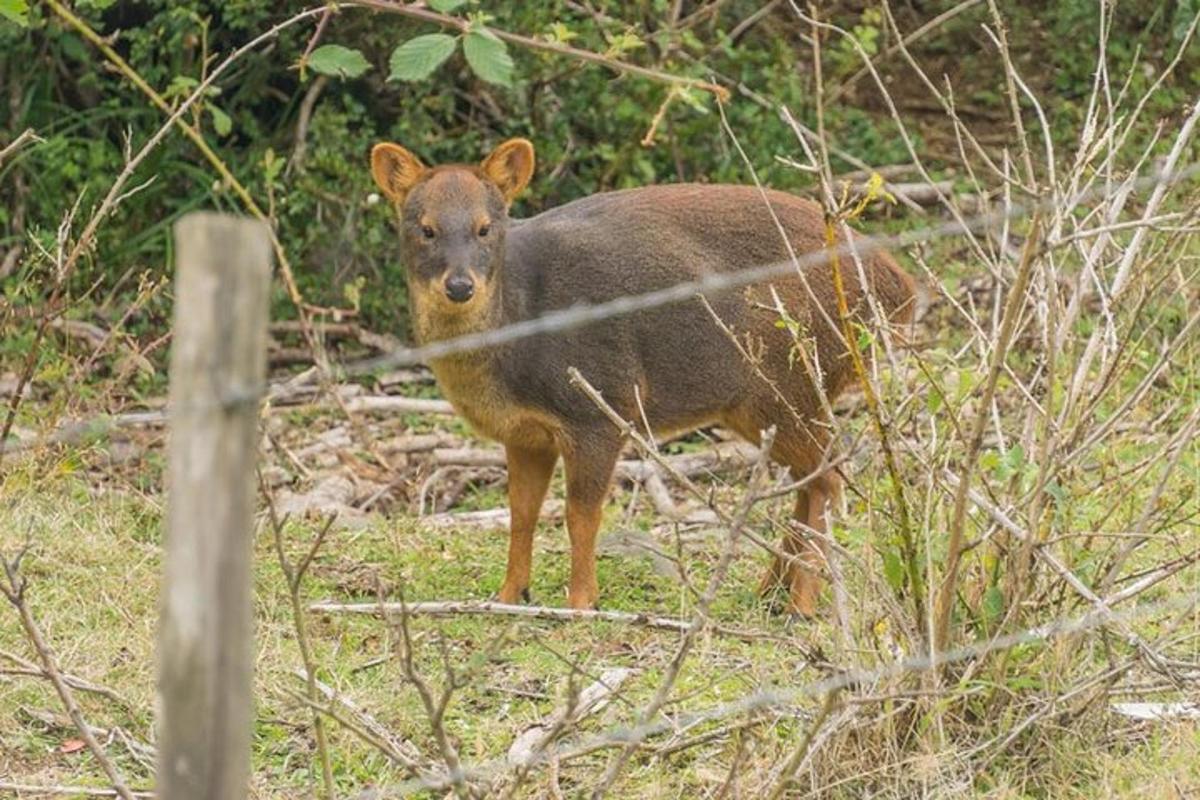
(0, 0, 1200, 333)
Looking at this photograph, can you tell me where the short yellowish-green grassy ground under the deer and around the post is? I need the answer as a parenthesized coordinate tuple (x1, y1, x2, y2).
(0, 388, 1200, 798)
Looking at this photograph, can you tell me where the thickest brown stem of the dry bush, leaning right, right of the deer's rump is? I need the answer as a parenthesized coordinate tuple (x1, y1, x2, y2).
(932, 211, 1040, 650)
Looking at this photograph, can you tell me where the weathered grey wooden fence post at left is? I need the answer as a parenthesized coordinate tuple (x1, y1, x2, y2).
(157, 213, 271, 800)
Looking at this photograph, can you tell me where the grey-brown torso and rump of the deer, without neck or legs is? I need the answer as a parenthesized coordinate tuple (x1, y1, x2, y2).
(497, 184, 912, 438)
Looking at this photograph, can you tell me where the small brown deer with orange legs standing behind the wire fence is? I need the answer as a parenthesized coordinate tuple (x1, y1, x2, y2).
(371, 139, 913, 616)
